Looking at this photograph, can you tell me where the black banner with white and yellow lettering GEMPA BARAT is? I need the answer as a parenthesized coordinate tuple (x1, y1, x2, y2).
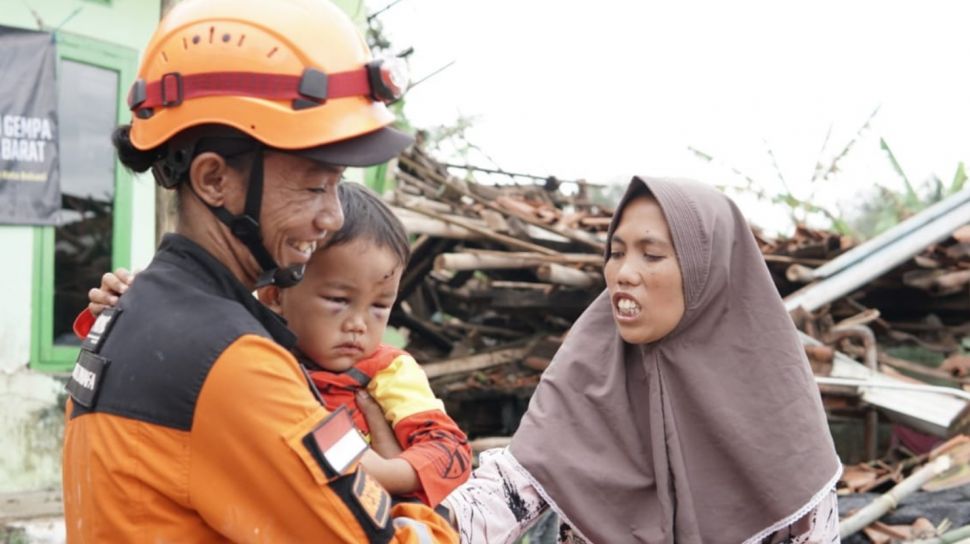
(0, 26, 61, 225)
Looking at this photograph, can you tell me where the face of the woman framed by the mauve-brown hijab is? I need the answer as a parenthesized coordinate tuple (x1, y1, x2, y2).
(604, 196, 685, 344)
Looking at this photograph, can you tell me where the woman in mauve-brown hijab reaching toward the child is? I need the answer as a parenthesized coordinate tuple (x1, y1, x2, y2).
(446, 178, 841, 544)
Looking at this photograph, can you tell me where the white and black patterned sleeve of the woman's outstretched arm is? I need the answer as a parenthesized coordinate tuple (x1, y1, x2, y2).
(442, 448, 549, 544)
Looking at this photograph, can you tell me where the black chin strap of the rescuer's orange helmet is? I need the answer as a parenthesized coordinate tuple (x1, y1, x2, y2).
(203, 147, 306, 288)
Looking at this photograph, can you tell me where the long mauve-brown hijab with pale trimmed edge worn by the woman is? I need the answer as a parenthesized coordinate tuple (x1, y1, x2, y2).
(511, 178, 841, 544)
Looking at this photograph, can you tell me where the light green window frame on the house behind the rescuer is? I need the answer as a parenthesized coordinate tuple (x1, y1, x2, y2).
(30, 32, 138, 372)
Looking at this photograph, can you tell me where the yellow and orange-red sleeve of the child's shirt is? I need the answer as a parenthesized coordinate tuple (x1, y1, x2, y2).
(368, 353, 471, 506)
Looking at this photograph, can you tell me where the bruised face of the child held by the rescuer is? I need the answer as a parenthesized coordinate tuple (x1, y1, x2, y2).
(278, 239, 404, 372)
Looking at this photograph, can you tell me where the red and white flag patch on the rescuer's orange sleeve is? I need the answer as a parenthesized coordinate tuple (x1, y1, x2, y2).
(303, 406, 368, 478)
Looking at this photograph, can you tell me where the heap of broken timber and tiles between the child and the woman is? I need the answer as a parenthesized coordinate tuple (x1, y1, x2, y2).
(391, 147, 612, 435)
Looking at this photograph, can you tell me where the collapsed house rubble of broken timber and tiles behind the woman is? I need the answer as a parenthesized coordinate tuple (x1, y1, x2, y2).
(390, 143, 970, 542)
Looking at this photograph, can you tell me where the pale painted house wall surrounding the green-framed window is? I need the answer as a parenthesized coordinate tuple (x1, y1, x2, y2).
(0, 0, 159, 492)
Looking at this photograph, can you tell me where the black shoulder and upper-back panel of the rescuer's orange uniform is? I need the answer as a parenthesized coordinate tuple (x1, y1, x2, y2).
(71, 236, 286, 431)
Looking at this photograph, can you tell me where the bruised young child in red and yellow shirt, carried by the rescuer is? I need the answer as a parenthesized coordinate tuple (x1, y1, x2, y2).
(75, 183, 471, 506)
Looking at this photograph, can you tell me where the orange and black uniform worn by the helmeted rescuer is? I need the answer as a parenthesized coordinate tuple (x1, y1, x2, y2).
(63, 235, 458, 543)
